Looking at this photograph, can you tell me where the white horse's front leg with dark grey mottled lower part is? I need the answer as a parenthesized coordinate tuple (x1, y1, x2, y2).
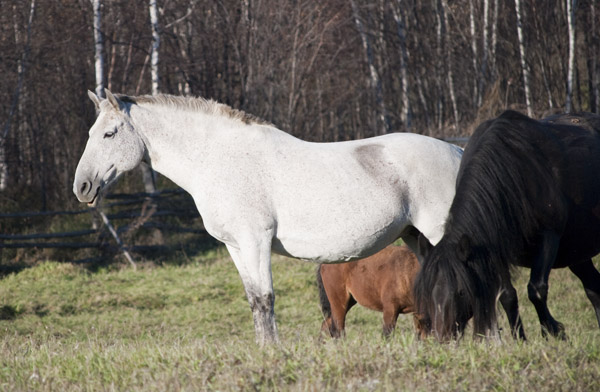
(227, 240, 279, 346)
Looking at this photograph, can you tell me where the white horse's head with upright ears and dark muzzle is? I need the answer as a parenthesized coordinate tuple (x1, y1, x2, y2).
(73, 90, 146, 206)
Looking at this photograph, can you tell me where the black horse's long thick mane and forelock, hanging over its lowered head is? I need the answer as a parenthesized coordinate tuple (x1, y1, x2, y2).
(415, 111, 576, 333)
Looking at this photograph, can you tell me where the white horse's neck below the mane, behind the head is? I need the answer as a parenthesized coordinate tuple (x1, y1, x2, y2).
(130, 100, 292, 193)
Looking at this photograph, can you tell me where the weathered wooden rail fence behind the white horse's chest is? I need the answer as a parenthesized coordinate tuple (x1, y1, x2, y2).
(0, 189, 216, 266)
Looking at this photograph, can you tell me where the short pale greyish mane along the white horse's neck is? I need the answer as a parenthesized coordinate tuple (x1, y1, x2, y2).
(117, 94, 273, 126)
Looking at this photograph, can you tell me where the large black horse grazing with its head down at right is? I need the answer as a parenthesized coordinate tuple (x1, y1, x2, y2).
(414, 111, 600, 340)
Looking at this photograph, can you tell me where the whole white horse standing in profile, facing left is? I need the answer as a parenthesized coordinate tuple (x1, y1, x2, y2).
(73, 90, 462, 344)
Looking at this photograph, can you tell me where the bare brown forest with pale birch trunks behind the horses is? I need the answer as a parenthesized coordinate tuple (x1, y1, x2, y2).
(0, 0, 600, 211)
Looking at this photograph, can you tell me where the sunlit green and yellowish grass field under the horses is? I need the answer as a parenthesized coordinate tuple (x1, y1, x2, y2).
(0, 250, 600, 391)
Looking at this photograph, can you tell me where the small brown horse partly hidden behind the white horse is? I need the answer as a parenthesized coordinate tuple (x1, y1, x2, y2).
(317, 245, 421, 338)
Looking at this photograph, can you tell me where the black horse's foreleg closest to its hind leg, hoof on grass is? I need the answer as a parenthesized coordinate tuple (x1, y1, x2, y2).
(527, 232, 566, 339)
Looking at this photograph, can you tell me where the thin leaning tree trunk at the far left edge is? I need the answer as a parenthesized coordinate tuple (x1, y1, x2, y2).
(0, 0, 36, 191)
